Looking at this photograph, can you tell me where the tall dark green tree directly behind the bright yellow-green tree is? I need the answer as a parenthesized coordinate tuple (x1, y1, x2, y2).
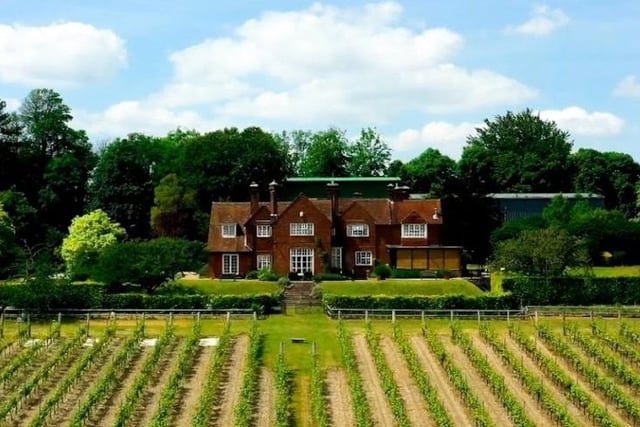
(89, 134, 158, 238)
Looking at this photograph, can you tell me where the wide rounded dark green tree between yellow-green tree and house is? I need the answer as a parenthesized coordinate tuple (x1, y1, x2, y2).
(92, 237, 206, 293)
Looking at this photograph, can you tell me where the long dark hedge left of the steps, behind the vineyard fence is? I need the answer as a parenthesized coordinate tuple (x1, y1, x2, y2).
(0, 284, 283, 312)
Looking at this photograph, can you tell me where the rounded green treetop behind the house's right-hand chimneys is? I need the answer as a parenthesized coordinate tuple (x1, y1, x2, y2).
(400, 148, 457, 197)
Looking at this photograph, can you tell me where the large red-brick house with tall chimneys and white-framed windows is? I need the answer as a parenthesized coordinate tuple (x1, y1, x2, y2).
(207, 182, 462, 277)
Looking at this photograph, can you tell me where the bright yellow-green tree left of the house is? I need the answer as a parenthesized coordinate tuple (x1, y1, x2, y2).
(60, 209, 126, 278)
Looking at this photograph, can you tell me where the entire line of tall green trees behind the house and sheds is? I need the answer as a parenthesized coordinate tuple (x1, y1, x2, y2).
(0, 89, 640, 276)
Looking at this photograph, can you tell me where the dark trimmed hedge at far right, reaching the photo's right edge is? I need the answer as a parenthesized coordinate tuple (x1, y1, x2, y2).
(502, 276, 640, 305)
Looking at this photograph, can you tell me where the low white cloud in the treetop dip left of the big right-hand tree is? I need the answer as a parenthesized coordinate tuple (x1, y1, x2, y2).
(391, 122, 482, 160)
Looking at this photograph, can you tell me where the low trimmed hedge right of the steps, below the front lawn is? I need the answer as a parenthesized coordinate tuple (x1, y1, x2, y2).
(322, 294, 518, 310)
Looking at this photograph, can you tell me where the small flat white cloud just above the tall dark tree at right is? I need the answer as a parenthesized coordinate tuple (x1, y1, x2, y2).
(540, 107, 624, 136)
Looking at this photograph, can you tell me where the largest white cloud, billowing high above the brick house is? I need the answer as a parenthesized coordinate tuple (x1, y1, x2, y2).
(150, 2, 537, 126)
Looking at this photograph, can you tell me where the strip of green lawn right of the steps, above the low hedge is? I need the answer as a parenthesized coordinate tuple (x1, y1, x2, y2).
(321, 279, 482, 296)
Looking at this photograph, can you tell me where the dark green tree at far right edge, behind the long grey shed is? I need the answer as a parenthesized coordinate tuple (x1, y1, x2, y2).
(570, 148, 640, 218)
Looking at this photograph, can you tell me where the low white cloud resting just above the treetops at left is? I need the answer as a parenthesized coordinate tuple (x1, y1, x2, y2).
(73, 101, 216, 138)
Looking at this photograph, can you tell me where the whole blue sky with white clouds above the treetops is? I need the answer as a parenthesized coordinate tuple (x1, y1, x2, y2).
(0, 0, 640, 162)
